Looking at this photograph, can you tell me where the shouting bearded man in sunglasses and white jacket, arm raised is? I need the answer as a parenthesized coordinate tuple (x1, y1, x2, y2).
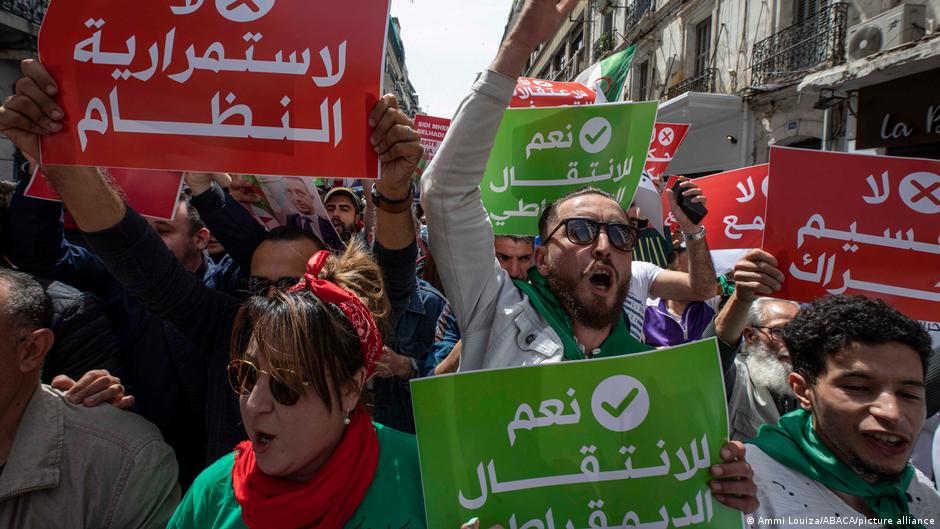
(418, 0, 756, 511)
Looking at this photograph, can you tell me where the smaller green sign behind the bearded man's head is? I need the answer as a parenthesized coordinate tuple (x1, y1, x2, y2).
(480, 102, 657, 235)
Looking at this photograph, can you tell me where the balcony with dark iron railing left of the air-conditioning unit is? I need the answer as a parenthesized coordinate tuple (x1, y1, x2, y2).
(751, 3, 848, 87)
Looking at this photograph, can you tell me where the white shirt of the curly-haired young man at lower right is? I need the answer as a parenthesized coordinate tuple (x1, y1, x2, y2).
(744, 444, 940, 529)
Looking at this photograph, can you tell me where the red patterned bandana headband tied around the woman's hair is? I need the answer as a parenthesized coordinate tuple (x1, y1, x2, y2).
(288, 250, 383, 378)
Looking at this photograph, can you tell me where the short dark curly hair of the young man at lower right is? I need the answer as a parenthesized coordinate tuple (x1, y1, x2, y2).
(783, 296, 931, 384)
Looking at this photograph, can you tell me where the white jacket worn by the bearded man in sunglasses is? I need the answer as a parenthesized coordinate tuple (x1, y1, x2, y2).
(421, 71, 564, 371)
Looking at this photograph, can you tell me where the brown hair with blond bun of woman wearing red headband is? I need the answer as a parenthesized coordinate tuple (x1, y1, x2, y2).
(230, 240, 391, 409)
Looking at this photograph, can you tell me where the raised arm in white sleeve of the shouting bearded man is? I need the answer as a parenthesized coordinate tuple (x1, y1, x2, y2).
(421, 0, 578, 369)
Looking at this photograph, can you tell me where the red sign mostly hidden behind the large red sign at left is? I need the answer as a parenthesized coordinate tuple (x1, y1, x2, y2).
(23, 169, 183, 220)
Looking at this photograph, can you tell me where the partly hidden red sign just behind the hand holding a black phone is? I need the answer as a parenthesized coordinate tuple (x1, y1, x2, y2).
(663, 164, 768, 250)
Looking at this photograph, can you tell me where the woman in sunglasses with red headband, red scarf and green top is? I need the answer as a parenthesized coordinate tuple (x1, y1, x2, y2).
(168, 245, 426, 529)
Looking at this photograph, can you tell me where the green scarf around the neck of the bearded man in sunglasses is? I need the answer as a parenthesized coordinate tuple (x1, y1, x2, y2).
(512, 267, 652, 360)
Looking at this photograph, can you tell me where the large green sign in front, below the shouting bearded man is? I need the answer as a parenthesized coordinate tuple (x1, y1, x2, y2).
(411, 339, 742, 529)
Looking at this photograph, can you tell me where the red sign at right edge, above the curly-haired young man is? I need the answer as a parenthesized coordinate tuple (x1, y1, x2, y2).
(764, 147, 940, 321)
